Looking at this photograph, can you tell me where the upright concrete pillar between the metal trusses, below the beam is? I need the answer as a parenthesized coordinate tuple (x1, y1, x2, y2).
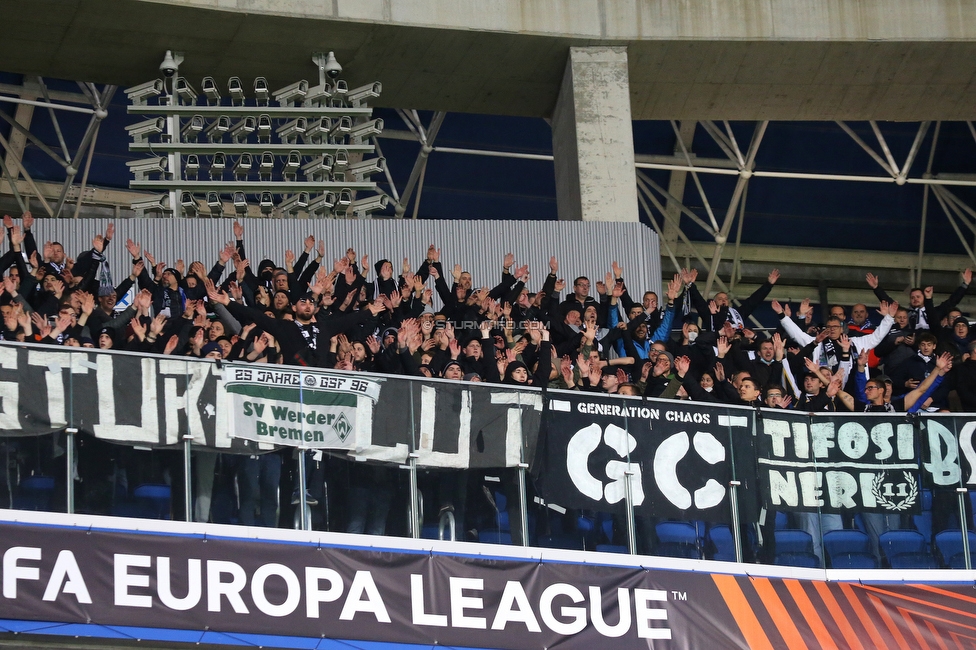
(552, 47, 638, 221)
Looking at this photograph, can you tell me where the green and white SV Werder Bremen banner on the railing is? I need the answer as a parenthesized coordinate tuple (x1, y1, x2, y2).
(224, 364, 380, 450)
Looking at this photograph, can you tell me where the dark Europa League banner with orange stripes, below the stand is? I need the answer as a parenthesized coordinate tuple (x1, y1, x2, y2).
(0, 514, 972, 650)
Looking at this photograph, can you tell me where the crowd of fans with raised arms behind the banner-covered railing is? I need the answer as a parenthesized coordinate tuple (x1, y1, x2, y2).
(0, 213, 976, 411)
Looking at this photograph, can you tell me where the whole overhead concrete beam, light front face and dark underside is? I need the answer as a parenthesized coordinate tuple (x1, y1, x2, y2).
(0, 0, 976, 121)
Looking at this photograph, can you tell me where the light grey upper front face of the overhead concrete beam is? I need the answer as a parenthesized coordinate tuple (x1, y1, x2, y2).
(141, 0, 976, 41)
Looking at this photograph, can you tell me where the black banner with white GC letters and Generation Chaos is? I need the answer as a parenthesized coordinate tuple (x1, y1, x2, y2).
(535, 392, 755, 522)
